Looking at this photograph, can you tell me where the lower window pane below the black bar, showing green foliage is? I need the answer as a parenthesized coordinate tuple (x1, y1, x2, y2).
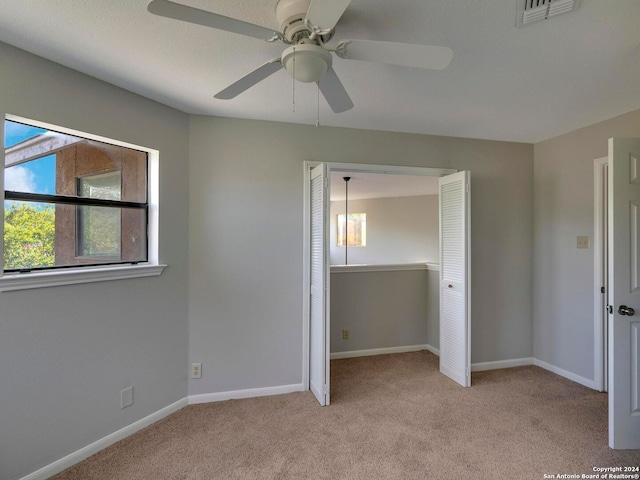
(4, 201, 147, 270)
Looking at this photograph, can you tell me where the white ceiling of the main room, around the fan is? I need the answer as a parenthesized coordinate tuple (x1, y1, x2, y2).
(0, 0, 640, 142)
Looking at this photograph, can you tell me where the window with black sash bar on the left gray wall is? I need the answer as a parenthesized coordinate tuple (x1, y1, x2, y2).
(3, 116, 149, 283)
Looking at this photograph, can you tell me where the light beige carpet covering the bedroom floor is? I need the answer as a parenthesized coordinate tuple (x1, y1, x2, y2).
(53, 352, 640, 480)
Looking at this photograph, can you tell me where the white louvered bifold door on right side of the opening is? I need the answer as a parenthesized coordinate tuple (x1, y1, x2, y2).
(439, 171, 471, 387)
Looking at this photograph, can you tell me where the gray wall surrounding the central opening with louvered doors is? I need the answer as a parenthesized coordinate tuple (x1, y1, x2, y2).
(189, 116, 533, 394)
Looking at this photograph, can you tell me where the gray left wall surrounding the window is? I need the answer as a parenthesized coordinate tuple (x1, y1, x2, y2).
(0, 43, 188, 480)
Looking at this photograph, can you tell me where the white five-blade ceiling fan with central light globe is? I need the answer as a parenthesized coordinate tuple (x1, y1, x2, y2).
(147, 0, 453, 113)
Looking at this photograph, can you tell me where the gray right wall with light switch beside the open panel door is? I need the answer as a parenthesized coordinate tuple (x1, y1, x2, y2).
(533, 110, 640, 379)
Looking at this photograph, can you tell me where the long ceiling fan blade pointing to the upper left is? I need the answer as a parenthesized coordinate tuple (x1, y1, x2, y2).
(147, 0, 283, 40)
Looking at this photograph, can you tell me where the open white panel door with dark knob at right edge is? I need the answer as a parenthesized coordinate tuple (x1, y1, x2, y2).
(609, 138, 640, 449)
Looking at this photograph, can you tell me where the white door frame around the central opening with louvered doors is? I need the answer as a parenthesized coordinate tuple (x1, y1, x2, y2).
(302, 160, 458, 391)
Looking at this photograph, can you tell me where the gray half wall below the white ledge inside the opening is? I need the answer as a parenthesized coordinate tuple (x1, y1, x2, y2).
(331, 270, 440, 353)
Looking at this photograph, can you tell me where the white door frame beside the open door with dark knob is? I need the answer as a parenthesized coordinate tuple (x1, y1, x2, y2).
(593, 157, 609, 392)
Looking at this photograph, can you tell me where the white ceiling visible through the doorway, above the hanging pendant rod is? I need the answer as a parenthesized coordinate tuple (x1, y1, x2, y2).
(331, 171, 438, 202)
